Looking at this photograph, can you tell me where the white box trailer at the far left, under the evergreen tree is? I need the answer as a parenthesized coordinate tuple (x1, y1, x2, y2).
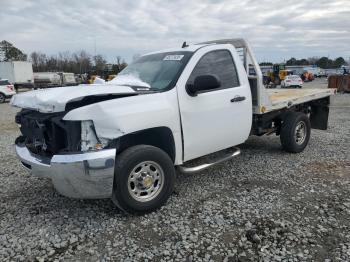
(0, 61, 34, 90)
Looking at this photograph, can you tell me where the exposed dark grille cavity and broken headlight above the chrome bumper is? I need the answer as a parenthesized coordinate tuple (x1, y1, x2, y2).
(16, 110, 110, 157)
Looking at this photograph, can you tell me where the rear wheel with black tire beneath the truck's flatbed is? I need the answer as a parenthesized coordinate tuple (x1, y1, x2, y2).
(280, 112, 311, 153)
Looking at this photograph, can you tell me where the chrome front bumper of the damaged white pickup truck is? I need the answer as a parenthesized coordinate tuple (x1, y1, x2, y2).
(15, 144, 116, 199)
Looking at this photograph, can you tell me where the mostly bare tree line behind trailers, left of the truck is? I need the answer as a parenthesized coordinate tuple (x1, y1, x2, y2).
(0, 41, 127, 76)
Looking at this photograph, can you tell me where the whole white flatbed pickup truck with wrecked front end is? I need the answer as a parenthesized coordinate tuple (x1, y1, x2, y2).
(11, 39, 334, 213)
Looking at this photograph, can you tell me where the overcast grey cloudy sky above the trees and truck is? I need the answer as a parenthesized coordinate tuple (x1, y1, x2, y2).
(0, 0, 350, 62)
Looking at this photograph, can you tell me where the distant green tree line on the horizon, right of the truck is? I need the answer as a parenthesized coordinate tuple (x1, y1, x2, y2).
(260, 56, 348, 69)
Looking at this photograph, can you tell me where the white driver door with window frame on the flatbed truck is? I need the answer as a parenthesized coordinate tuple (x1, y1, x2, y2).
(178, 45, 252, 161)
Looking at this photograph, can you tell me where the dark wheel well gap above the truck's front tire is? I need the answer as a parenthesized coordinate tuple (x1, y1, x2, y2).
(112, 127, 176, 162)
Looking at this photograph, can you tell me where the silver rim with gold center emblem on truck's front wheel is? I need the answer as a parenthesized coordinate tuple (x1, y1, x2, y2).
(128, 161, 164, 202)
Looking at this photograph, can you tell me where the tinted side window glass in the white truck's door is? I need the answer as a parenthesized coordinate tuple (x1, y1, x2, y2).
(187, 50, 239, 89)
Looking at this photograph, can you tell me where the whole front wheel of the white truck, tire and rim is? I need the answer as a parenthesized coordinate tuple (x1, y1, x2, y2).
(112, 145, 175, 214)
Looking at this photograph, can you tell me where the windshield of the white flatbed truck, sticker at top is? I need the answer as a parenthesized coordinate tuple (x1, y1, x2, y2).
(110, 52, 192, 91)
